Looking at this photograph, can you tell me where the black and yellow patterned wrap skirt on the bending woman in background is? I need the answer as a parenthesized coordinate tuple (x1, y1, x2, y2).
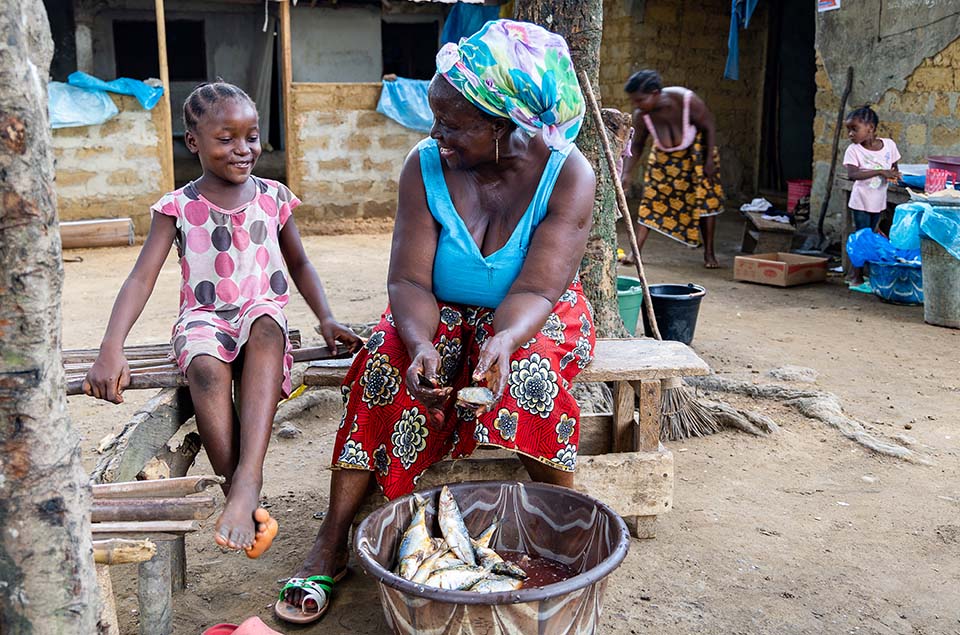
(637, 135, 723, 247)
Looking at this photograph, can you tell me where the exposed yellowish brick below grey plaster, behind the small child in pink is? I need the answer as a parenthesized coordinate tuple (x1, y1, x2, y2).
(811, 38, 960, 237)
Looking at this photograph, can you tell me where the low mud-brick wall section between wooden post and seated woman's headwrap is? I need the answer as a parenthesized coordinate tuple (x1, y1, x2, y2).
(287, 82, 426, 230)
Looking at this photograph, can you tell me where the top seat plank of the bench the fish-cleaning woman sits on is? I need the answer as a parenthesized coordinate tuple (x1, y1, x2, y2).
(303, 339, 710, 386)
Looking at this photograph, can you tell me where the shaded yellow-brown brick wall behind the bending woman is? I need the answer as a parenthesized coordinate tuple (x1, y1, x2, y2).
(600, 0, 767, 199)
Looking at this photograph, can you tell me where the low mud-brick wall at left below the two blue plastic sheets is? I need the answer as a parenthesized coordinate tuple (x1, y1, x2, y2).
(53, 94, 172, 235)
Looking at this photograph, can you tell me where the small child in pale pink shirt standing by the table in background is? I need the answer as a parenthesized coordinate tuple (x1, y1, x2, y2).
(843, 106, 900, 293)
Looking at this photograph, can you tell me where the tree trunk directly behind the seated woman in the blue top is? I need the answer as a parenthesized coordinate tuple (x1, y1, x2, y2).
(515, 0, 628, 337)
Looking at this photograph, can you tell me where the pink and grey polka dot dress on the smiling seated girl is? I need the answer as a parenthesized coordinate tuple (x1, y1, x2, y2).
(150, 176, 300, 397)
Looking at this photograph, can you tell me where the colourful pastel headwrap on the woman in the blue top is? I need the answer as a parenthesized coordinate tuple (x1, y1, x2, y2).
(437, 20, 586, 150)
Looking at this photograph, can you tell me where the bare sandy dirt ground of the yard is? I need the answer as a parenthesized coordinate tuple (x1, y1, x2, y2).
(63, 213, 960, 635)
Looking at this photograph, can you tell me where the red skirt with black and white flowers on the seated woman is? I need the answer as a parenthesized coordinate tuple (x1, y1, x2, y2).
(333, 281, 596, 499)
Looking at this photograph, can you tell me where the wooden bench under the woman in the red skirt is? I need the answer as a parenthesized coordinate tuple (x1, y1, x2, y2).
(303, 339, 710, 538)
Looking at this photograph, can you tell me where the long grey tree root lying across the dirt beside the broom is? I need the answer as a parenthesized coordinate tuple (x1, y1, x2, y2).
(687, 375, 929, 464)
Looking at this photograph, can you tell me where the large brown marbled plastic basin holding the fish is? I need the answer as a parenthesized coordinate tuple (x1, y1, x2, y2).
(354, 481, 630, 635)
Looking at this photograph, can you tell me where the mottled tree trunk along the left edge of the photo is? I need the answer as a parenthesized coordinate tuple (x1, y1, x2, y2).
(0, 0, 99, 635)
